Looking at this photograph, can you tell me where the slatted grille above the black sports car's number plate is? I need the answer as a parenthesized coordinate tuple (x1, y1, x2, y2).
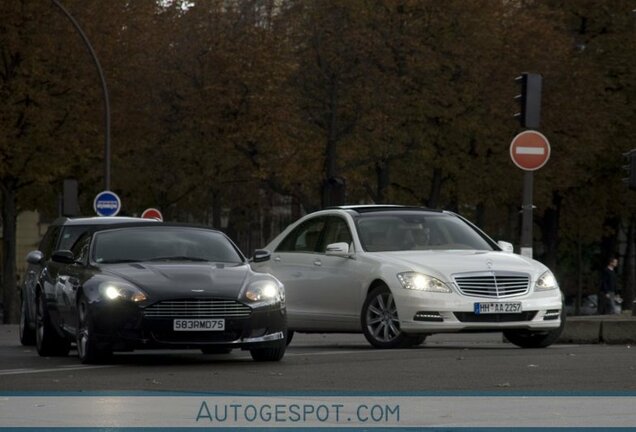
(144, 299, 252, 318)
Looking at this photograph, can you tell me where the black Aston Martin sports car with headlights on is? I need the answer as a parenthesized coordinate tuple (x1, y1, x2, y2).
(36, 223, 286, 363)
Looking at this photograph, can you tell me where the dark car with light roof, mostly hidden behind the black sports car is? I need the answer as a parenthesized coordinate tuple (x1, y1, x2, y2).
(19, 217, 156, 345)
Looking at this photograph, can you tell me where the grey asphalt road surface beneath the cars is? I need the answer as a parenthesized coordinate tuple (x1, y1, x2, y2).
(0, 325, 636, 392)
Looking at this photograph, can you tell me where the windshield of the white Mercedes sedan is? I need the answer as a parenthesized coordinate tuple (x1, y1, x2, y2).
(356, 211, 495, 252)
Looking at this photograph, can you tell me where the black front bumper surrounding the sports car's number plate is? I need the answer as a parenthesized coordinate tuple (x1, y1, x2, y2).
(91, 303, 287, 351)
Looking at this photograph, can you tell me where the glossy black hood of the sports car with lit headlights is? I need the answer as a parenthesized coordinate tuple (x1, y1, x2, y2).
(105, 262, 250, 299)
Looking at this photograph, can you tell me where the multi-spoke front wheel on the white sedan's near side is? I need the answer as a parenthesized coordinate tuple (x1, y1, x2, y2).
(361, 285, 410, 349)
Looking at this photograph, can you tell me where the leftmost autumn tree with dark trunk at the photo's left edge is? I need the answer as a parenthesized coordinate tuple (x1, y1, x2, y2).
(0, 1, 98, 322)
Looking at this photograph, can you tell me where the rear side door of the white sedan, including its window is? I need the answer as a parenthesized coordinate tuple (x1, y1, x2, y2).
(264, 216, 327, 330)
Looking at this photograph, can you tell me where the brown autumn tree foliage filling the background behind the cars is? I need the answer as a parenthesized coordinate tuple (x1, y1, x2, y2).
(0, 0, 636, 320)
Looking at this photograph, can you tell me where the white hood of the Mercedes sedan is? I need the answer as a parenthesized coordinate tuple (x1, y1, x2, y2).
(373, 250, 547, 280)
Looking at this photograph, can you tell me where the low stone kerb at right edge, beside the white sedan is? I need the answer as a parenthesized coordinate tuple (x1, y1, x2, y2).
(557, 311, 636, 344)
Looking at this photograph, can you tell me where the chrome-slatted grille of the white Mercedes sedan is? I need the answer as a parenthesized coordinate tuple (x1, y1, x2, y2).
(453, 272, 530, 298)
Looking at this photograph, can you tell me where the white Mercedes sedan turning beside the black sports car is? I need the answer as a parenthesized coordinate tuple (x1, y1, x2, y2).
(252, 206, 565, 348)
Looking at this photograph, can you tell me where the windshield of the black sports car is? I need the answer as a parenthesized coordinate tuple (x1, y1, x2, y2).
(92, 226, 243, 264)
